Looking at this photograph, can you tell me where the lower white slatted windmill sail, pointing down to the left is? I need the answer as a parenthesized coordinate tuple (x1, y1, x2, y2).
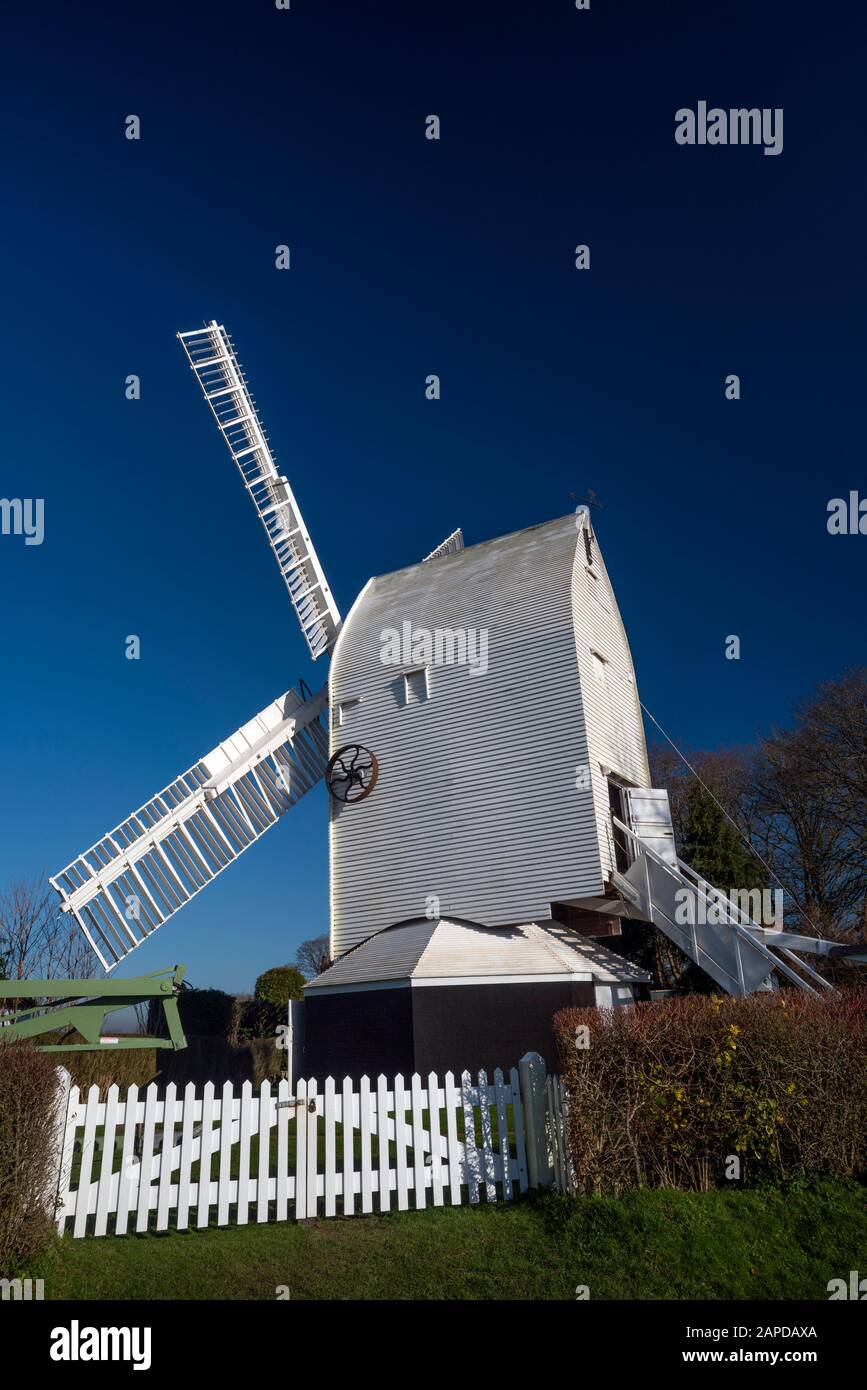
(50, 687, 328, 970)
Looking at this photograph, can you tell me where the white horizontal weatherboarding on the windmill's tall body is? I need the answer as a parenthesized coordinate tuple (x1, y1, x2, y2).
(329, 516, 646, 955)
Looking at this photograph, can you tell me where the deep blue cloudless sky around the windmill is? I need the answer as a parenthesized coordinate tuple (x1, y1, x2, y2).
(0, 0, 867, 990)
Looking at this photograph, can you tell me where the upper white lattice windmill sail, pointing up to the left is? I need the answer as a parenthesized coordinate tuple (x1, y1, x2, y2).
(178, 320, 340, 660)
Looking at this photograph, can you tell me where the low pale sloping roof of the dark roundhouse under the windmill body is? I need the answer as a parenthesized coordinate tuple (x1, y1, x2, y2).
(304, 917, 650, 991)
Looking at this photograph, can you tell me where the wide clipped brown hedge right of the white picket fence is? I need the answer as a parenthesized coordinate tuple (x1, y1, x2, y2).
(554, 990, 867, 1194)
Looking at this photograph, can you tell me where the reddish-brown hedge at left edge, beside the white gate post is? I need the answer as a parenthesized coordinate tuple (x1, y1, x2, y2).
(0, 1043, 60, 1279)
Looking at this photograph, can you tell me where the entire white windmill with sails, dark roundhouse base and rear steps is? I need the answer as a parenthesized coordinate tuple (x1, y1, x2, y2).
(51, 321, 855, 1074)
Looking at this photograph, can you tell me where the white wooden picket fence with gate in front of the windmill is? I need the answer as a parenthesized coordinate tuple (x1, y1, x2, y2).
(58, 1055, 544, 1236)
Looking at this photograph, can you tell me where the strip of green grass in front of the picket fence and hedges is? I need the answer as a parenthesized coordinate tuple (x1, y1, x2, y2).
(28, 1182, 867, 1300)
